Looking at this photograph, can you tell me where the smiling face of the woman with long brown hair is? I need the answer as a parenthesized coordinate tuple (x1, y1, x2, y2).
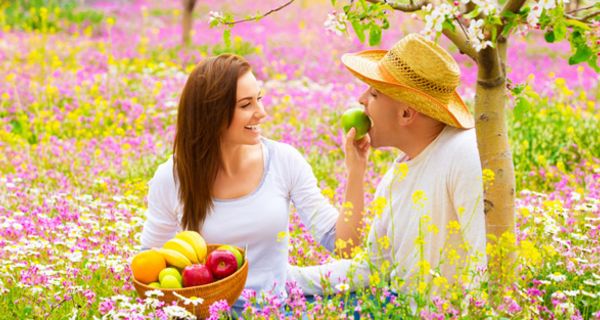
(222, 72, 267, 144)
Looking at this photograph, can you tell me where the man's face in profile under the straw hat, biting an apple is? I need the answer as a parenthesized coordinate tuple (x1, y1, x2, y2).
(358, 87, 397, 148)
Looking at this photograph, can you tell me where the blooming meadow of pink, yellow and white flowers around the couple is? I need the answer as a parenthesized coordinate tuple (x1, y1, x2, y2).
(0, 0, 600, 319)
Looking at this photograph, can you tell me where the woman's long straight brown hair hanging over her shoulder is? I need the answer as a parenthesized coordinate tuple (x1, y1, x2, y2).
(173, 54, 251, 232)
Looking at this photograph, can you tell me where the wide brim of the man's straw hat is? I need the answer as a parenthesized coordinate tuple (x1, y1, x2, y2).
(342, 50, 475, 129)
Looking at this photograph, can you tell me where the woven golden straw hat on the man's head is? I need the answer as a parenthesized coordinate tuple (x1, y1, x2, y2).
(342, 33, 474, 128)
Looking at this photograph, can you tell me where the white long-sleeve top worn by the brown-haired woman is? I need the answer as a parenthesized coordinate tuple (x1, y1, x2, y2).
(141, 139, 338, 295)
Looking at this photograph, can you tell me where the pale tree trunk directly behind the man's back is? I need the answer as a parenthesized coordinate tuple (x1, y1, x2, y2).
(475, 43, 515, 238)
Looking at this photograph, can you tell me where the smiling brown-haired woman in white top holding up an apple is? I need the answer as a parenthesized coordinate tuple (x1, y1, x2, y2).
(141, 54, 368, 307)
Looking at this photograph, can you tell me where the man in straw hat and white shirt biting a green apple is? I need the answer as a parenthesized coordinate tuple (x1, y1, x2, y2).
(288, 34, 486, 294)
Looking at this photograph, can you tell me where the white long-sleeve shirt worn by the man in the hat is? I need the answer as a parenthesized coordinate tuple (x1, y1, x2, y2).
(288, 126, 486, 294)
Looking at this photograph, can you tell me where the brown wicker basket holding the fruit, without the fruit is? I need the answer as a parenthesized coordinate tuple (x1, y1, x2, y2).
(132, 244, 248, 318)
